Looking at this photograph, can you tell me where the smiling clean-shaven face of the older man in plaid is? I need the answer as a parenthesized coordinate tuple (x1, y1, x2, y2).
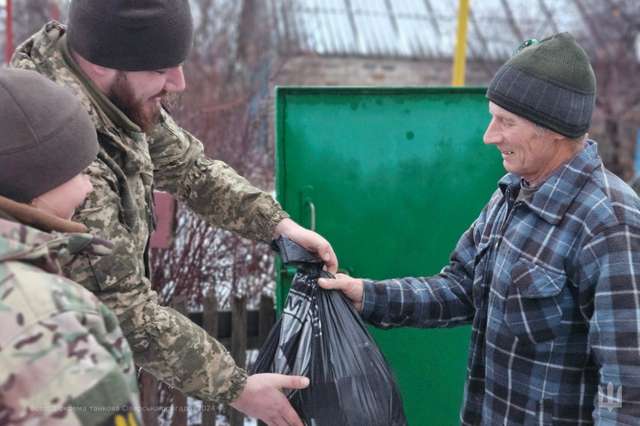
(483, 102, 582, 185)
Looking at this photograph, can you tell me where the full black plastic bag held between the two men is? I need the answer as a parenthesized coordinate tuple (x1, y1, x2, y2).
(253, 237, 407, 426)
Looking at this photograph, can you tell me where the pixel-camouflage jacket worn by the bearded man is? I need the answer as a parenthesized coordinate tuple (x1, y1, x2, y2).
(11, 22, 287, 402)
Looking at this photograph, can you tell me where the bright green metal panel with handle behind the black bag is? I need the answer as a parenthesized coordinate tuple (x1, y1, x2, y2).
(276, 87, 504, 426)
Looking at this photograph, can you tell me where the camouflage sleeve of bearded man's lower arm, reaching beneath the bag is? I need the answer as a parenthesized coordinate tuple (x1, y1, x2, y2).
(65, 161, 246, 402)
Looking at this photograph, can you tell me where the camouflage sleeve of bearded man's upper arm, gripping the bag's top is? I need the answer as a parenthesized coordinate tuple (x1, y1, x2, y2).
(149, 113, 288, 242)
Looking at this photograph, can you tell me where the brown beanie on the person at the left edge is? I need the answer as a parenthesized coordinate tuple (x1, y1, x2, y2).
(0, 69, 98, 202)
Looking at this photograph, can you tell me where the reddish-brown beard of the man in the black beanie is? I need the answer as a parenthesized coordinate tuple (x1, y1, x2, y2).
(107, 71, 167, 133)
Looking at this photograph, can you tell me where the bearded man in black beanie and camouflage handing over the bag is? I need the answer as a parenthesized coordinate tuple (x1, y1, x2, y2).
(11, 0, 337, 424)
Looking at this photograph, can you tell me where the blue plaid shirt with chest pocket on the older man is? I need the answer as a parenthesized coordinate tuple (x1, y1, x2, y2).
(362, 141, 640, 425)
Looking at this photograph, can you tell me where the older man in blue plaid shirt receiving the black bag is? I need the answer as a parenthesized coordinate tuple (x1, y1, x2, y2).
(320, 33, 640, 425)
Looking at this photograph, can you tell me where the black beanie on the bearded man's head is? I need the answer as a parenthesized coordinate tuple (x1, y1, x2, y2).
(68, 0, 193, 71)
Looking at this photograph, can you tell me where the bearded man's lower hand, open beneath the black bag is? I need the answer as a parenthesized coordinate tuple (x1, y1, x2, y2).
(229, 374, 309, 426)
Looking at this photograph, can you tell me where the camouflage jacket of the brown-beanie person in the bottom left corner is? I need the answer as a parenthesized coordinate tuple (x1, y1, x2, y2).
(0, 219, 140, 425)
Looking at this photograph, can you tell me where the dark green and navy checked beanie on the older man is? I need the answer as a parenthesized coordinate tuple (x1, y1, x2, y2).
(487, 33, 596, 138)
